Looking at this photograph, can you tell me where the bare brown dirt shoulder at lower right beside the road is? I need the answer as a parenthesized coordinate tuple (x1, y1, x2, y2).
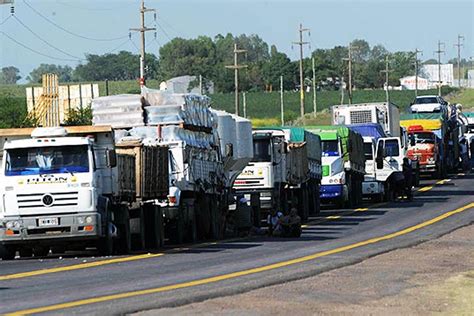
(142, 225, 474, 315)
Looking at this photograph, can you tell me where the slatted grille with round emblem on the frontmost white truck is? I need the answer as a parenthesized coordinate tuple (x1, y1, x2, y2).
(16, 191, 79, 208)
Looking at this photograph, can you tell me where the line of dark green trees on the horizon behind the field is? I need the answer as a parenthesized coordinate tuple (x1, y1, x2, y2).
(0, 34, 467, 92)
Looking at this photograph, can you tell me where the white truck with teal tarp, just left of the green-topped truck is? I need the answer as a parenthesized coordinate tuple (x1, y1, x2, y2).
(234, 127, 322, 220)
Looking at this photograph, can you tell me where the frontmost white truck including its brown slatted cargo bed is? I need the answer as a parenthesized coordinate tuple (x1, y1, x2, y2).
(0, 126, 168, 260)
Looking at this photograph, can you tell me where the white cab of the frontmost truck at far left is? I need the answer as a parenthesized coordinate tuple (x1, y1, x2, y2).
(0, 127, 115, 258)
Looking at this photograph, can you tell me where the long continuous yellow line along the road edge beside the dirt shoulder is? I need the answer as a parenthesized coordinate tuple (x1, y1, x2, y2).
(6, 203, 474, 315)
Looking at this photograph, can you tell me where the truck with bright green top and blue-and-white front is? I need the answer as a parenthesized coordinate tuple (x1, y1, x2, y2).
(305, 126, 365, 207)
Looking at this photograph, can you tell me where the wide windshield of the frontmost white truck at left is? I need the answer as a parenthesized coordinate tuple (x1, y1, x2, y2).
(5, 145, 89, 176)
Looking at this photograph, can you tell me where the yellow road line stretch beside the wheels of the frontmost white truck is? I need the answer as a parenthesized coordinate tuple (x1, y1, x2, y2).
(0, 253, 164, 281)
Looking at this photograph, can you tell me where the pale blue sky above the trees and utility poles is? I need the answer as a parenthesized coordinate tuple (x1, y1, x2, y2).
(0, 0, 474, 82)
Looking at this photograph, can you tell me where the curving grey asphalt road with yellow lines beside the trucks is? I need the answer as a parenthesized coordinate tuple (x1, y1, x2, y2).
(0, 175, 474, 315)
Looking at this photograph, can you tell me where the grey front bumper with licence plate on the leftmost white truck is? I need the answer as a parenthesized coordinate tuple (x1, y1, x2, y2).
(0, 213, 102, 245)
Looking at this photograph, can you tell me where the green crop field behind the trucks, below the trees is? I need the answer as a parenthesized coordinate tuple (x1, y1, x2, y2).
(0, 80, 460, 127)
